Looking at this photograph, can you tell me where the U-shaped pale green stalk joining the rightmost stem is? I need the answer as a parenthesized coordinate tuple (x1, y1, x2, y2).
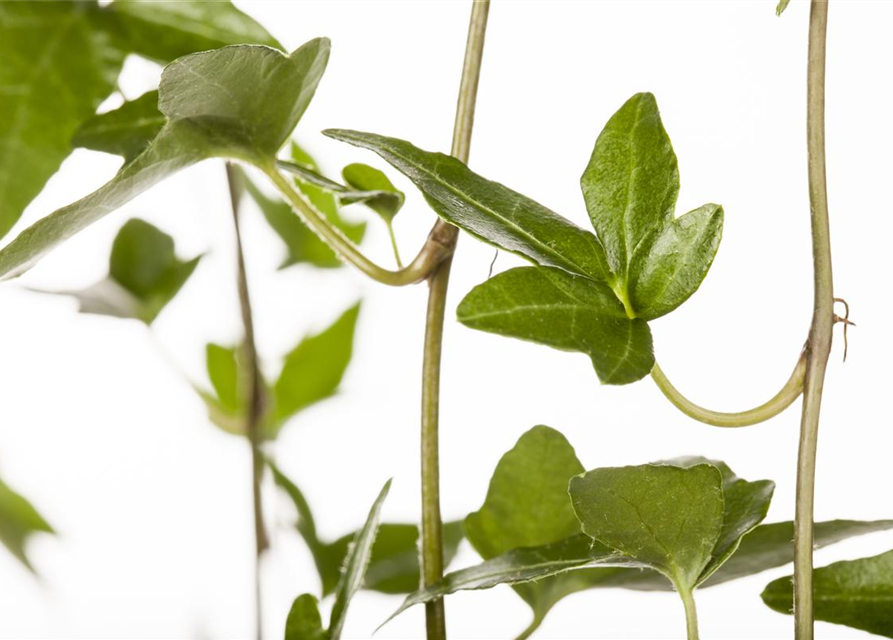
(651, 352, 806, 428)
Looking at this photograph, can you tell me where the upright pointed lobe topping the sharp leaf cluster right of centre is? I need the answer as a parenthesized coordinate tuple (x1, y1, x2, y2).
(580, 93, 679, 288)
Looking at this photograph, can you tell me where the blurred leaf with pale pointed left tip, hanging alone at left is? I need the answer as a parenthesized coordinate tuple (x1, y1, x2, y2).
(33, 218, 201, 324)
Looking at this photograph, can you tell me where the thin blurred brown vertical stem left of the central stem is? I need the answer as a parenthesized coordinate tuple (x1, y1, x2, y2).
(226, 163, 269, 640)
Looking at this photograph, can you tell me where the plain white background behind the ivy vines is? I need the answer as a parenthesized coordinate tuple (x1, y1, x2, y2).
(0, 0, 893, 638)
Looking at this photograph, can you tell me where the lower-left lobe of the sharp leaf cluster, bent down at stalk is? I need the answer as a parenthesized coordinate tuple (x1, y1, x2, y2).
(457, 267, 654, 384)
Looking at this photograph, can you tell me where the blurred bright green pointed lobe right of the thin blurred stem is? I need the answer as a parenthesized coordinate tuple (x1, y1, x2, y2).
(270, 303, 360, 437)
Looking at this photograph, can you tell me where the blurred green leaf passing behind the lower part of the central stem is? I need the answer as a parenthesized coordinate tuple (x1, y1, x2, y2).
(269, 463, 463, 596)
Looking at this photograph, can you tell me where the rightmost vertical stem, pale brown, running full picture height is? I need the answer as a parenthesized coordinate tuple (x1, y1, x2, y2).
(794, 0, 834, 640)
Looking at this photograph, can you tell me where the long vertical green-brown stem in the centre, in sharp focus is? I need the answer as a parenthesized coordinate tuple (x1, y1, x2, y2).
(421, 5, 490, 640)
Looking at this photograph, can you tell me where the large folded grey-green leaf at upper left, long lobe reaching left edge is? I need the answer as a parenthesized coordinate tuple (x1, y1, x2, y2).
(0, 39, 329, 277)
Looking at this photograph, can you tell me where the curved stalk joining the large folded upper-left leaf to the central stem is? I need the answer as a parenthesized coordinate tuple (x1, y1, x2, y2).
(262, 162, 455, 287)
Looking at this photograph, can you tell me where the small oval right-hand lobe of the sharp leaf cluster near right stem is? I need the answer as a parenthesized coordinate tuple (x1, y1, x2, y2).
(630, 204, 723, 320)
